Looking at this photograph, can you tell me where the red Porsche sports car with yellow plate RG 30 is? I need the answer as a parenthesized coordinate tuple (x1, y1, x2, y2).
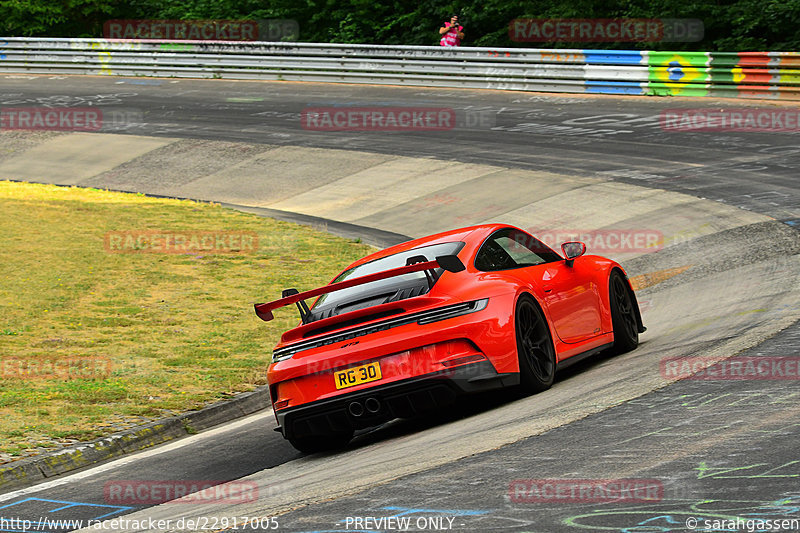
(255, 224, 645, 453)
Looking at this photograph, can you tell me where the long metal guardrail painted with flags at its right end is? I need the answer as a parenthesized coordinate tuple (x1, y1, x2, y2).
(0, 37, 800, 100)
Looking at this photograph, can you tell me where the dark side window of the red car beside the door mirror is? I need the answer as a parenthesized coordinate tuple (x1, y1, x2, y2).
(475, 228, 562, 271)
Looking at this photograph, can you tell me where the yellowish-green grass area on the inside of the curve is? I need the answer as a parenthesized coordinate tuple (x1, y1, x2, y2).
(0, 181, 371, 455)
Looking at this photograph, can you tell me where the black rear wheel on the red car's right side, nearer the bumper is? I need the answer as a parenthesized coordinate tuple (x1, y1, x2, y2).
(514, 295, 556, 394)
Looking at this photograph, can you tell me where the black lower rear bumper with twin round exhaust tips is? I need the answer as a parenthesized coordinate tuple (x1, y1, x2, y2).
(275, 361, 519, 439)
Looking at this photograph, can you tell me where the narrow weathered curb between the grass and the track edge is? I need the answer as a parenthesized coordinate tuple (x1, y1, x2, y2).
(0, 385, 270, 491)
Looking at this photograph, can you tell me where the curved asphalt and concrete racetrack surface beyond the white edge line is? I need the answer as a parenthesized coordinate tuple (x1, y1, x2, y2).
(0, 76, 800, 533)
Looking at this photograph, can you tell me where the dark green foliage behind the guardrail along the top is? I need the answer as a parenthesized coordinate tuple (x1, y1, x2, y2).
(0, 0, 800, 51)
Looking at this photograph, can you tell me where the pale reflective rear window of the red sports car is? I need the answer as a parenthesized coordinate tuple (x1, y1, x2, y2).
(311, 241, 464, 320)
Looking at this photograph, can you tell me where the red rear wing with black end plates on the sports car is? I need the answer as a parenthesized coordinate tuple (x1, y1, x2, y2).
(254, 255, 466, 324)
